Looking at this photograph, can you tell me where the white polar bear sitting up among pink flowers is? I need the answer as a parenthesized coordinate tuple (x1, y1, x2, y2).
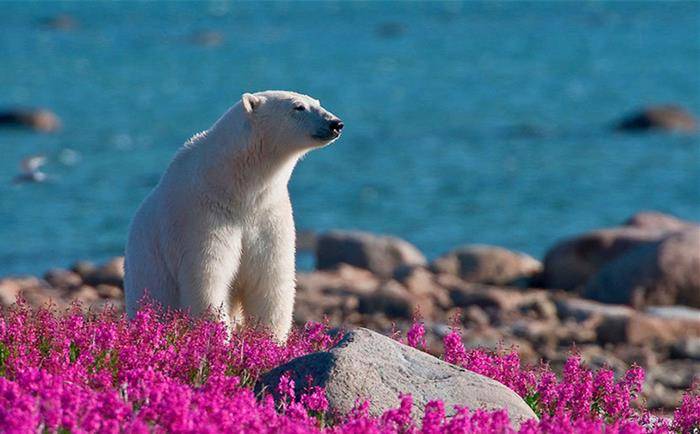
(124, 91, 343, 340)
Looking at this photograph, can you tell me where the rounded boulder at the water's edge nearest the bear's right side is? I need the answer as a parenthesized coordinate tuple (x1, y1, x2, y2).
(316, 231, 427, 277)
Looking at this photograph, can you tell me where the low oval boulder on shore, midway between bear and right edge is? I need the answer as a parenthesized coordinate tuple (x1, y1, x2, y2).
(430, 245, 542, 285)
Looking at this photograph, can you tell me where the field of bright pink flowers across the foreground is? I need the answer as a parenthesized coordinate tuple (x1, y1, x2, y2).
(0, 303, 700, 434)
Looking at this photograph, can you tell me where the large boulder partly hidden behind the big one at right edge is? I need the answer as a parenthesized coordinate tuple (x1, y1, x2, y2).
(542, 226, 669, 291)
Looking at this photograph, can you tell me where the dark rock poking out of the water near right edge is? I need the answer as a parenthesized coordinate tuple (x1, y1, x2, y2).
(616, 105, 697, 132)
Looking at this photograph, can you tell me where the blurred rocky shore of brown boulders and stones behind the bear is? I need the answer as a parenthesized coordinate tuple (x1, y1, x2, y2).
(0, 212, 700, 410)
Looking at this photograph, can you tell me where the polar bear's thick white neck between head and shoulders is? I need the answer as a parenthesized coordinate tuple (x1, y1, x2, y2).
(194, 104, 302, 207)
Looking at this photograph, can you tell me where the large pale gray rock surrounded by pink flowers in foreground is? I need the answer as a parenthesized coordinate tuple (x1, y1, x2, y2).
(258, 328, 536, 427)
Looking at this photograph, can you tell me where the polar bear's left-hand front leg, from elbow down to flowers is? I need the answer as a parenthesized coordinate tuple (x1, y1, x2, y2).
(177, 232, 241, 328)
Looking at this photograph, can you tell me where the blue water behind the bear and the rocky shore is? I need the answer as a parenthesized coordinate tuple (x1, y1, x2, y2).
(0, 2, 700, 275)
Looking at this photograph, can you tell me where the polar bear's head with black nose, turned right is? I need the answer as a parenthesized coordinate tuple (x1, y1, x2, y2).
(241, 91, 343, 151)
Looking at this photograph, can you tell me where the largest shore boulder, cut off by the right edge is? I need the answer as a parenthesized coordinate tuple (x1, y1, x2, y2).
(584, 227, 700, 308)
